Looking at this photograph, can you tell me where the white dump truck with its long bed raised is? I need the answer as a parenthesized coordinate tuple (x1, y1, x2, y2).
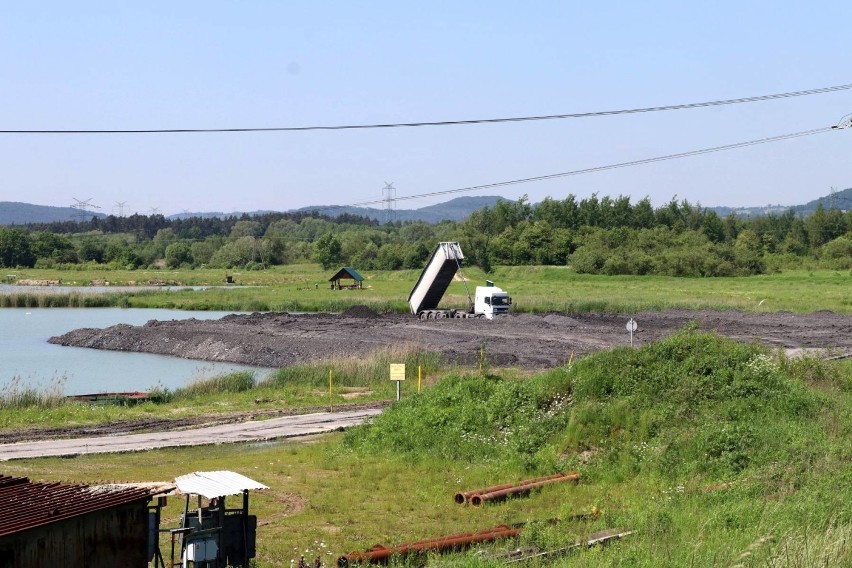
(408, 242, 512, 319)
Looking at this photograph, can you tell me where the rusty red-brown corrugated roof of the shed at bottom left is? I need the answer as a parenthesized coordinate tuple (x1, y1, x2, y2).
(0, 475, 150, 536)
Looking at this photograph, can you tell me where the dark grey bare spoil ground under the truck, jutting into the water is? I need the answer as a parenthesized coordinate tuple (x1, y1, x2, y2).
(50, 307, 852, 369)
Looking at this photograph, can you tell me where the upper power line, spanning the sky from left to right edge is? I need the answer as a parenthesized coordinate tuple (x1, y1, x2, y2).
(5, 84, 852, 134)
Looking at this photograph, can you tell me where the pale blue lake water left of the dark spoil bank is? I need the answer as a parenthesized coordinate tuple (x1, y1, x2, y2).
(0, 308, 269, 395)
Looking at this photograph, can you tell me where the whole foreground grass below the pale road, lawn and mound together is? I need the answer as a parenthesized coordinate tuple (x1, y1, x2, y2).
(4, 328, 852, 567)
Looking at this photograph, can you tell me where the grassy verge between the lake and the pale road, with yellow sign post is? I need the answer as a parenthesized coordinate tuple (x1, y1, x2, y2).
(0, 345, 445, 437)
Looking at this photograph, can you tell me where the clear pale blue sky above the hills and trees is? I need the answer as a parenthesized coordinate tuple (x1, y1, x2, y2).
(0, 0, 852, 215)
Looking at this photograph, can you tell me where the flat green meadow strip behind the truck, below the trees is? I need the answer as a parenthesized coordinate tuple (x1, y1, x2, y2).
(0, 264, 852, 314)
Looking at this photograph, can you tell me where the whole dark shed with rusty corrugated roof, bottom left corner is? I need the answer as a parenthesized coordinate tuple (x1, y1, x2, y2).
(0, 475, 151, 568)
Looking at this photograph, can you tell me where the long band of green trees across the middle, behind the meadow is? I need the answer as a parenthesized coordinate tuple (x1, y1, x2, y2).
(0, 194, 852, 276)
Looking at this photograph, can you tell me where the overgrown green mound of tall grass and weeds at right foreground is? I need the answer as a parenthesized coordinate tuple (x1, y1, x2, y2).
(343, 326, 852, 566)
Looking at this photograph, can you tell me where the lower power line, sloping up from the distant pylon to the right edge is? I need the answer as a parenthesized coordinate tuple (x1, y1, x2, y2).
(346, 125, 844, 209)
